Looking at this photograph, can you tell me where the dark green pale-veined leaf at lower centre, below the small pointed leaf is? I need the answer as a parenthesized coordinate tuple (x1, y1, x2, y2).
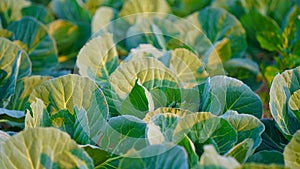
(98, 115, 147, 155)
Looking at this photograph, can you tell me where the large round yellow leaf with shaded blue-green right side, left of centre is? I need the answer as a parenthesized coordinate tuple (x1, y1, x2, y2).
(28, 75, 108, 144)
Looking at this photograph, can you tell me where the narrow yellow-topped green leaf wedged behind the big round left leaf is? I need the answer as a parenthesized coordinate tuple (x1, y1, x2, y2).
(7, 76, 51, 110)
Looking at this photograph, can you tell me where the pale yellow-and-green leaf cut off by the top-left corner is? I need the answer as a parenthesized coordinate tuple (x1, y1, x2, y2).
(0, 0, 30, 28)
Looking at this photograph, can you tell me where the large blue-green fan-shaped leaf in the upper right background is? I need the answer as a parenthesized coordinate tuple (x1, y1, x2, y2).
(187, 7, 247, 57)
